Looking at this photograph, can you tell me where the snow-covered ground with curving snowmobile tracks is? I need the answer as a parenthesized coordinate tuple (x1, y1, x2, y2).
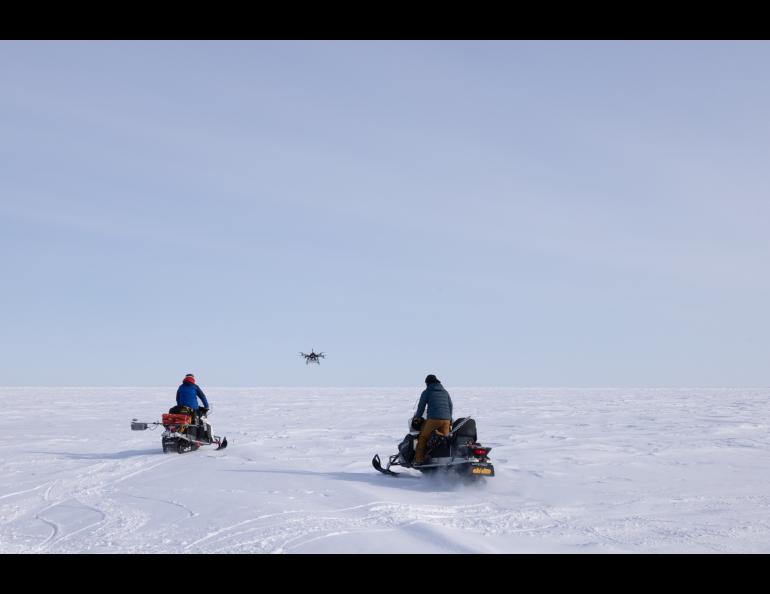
(0, 386, 770, 553)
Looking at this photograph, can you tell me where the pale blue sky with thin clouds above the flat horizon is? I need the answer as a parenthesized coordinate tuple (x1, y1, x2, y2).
(0, 41, 770, 387)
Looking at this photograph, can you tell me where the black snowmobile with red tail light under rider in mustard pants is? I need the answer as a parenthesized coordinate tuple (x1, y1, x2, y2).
(372, 417, 495, 479)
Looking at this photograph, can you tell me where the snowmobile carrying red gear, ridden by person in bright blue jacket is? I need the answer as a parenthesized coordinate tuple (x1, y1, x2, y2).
(131, 406, 227, 454)
